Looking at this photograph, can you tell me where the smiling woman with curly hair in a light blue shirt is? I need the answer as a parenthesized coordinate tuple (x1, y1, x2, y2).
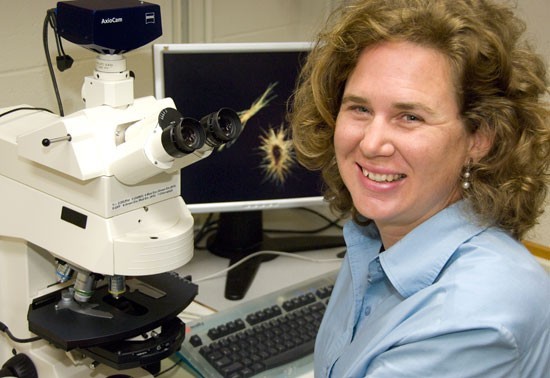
(290, 0, 550, 377)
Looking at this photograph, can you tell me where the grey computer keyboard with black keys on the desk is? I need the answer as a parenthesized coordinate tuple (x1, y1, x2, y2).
(181, 271, 337, 378)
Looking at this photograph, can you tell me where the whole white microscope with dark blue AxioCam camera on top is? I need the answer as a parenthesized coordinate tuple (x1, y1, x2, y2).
(0, 0, 242, 378)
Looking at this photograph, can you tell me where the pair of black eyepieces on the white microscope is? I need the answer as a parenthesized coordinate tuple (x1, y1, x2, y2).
(159, 108, 242, 158)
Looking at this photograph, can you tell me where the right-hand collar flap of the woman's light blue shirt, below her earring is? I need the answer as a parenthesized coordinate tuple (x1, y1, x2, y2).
(380, 201, 486, 297)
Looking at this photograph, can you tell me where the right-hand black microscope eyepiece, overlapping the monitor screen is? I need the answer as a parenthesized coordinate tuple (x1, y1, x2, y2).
(200, 108, 242, 147)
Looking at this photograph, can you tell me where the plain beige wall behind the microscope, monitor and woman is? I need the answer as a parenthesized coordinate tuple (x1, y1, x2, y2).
(0, 0, 550, 246)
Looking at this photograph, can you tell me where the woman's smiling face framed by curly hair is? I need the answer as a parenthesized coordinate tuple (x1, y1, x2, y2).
(334, 42, 475, 248)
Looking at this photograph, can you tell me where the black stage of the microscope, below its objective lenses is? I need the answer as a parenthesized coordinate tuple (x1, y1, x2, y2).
(27, 273, 198, 369)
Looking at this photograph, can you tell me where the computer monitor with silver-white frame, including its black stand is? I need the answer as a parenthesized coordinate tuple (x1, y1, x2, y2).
(154, 42, 343, 299)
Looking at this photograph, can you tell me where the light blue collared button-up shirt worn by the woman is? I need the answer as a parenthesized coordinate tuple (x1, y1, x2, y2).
(315, 202, 550, 378)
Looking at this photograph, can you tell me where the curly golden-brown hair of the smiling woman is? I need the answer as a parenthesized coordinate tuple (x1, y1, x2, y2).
(289, 0, 550, 238)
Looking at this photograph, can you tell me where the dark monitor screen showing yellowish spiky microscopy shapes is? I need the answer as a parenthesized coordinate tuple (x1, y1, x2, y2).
(164, 50, 321, 208)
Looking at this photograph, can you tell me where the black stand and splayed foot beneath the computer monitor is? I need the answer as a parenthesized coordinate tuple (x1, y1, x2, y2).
(207, 211, 345, 300)
